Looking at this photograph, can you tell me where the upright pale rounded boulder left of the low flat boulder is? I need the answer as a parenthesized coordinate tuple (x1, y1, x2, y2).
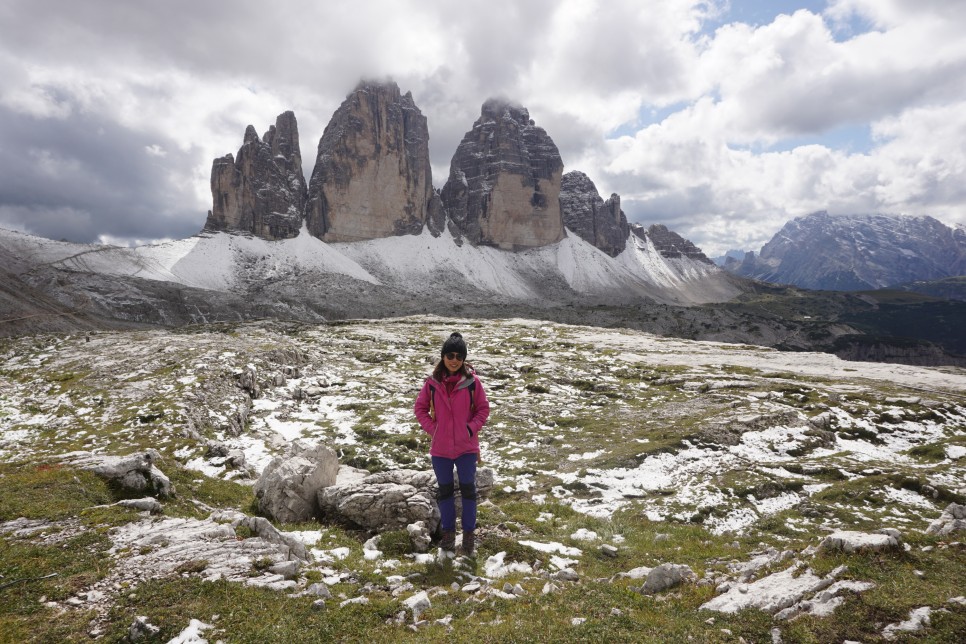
(254, 441, 339, 523)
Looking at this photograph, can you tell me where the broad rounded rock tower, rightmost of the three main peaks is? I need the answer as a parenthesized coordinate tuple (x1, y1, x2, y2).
(441, 99, 564, 250)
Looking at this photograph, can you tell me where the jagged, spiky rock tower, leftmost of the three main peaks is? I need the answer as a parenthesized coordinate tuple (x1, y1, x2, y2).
(205, 112, 307, 239)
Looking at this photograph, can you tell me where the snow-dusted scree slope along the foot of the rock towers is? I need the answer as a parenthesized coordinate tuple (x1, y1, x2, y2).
(0, 227, 736, 303)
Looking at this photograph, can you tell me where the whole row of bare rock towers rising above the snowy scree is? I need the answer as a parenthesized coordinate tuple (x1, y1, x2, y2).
(205, 81, 710, 263)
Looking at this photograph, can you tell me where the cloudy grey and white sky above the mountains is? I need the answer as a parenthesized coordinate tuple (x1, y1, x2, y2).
(0, 0, 966, 255)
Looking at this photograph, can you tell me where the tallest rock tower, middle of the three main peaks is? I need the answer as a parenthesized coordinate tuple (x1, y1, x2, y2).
(305, 82, 444, 242)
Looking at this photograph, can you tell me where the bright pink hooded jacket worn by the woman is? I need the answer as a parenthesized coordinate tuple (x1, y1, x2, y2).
(413, 374, 490, 459)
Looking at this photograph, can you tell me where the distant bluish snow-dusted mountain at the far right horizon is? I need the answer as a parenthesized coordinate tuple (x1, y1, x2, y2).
(728, 211, 966, 291)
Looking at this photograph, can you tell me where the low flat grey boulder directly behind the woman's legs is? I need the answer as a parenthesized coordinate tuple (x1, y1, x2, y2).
(318, 468, 495, 532)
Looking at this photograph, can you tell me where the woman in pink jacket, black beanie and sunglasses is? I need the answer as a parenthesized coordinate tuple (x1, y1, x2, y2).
(414, 333, 490, 555)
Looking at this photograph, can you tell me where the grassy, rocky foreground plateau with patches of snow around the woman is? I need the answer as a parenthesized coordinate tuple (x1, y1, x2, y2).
(0, 317, 966, 642)
